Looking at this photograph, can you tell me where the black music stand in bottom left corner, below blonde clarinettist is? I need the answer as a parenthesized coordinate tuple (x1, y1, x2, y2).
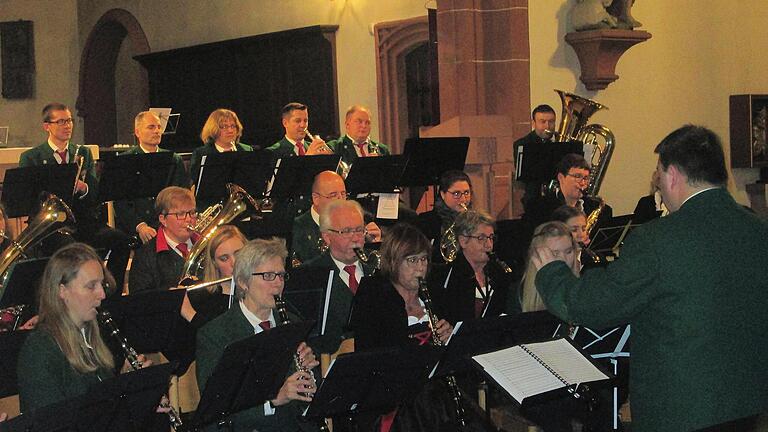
(0, 364, 171, 432)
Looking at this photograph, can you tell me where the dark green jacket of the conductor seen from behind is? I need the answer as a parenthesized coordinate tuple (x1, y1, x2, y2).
(536, 189, 768, 432)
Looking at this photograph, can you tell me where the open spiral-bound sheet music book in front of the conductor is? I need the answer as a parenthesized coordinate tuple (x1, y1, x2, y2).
(472, 338, 610, 404)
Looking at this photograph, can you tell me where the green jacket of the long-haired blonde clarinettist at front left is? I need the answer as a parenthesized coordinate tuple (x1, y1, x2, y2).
(17, 330, 114, 413)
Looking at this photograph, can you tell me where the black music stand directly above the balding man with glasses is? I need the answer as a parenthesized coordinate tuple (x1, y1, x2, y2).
(267, 155, 341, 199)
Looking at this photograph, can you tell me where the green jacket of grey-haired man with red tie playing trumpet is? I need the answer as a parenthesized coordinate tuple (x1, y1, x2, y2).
(303, 252, 374, 354)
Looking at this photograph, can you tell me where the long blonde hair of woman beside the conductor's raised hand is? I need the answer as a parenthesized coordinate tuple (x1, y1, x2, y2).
(520, 221, 579, 312)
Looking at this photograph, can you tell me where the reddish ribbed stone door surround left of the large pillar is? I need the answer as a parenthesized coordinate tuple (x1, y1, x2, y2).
(374, 16, 429, 153)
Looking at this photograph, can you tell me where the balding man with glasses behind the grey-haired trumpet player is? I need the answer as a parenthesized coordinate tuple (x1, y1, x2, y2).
(291, 171, 381, 262)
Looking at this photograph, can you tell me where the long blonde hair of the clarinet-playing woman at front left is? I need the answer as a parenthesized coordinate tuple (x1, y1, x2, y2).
(37, 243, 115, 373)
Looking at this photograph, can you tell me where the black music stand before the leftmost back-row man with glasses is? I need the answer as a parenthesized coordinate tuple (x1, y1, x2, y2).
(2, 163, 77, 218)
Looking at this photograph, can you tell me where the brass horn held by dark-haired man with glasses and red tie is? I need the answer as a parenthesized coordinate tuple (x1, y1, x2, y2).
(179, 183, 263, 285)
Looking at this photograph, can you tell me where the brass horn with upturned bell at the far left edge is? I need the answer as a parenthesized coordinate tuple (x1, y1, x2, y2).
(0, 194, 75, 286)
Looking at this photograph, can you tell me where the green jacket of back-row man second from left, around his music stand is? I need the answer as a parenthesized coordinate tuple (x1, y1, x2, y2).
(115, 146, 189, 235)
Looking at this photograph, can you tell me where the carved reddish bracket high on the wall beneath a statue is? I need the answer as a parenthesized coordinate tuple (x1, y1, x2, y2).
(565, 29, 651, 90)
